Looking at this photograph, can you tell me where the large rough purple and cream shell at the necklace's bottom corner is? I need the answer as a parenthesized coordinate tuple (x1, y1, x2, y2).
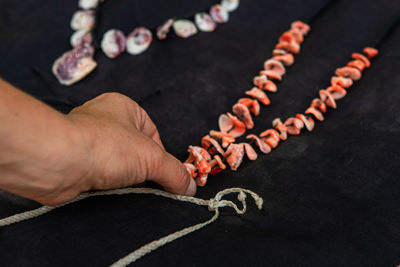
(52, 44, 97, 85)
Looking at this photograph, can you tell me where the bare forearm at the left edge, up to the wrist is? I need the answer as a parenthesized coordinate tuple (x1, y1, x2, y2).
(0, 80, 88, 205)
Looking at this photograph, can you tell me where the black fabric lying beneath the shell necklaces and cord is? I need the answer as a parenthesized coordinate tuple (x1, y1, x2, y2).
(0, 0, 400, 266)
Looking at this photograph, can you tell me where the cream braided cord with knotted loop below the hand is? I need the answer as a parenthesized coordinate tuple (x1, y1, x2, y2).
(0, 188, 263, 267)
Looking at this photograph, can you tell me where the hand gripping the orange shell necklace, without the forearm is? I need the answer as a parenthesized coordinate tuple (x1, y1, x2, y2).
(65, 93, 196, 203)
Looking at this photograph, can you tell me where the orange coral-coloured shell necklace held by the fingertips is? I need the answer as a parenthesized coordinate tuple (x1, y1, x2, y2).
(184, 18, 378, 186)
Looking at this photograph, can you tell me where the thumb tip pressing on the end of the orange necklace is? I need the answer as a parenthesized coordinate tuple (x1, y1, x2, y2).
(147, 150, 197, 196)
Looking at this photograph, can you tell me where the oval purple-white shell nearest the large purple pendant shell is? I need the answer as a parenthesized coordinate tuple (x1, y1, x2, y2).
(101, 29, 126, 58)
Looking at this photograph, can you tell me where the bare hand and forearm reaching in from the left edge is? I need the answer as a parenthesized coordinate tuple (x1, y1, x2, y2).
(0, 79, 196, 206)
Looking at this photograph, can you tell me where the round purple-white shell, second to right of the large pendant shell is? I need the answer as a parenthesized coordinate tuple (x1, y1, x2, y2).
(126, 27, 153, 55)
